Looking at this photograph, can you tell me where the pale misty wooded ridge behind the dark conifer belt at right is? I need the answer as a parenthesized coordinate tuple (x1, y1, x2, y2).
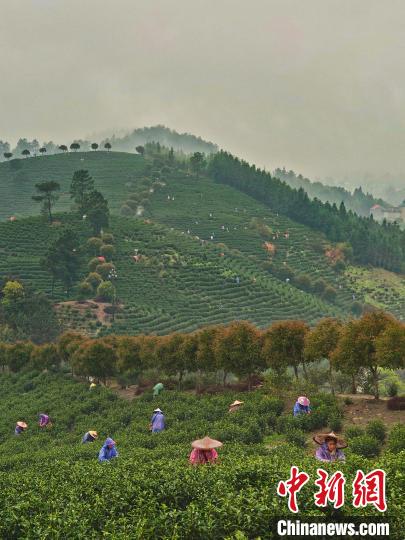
(273, 168, 390, 217)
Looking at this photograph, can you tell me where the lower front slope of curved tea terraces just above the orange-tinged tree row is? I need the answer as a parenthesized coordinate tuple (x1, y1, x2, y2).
(0, 214, 345, 334)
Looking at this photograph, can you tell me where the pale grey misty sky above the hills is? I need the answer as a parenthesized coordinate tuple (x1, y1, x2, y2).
(0, 0, 405, 181)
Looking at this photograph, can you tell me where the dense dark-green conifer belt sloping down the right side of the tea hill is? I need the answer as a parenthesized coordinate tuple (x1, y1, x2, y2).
(209, 151, 405, 272)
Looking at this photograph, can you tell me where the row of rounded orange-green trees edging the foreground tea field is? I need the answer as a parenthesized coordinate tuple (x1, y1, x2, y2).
(0, 312, 405, 398)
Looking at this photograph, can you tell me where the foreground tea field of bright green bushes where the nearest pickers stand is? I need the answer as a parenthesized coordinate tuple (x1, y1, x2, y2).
(0, 372, 405, 540)
